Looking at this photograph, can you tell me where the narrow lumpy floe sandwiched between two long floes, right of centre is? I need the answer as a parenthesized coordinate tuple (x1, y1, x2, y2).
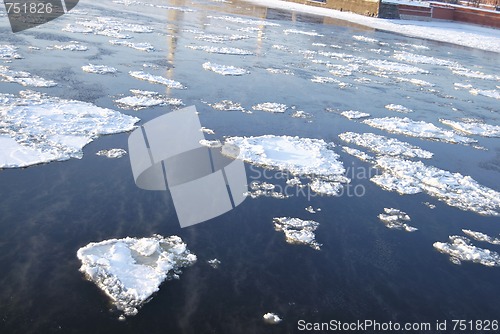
(339, 132, 433, 159)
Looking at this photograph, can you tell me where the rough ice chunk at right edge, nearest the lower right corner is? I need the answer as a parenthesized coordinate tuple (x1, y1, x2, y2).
(433, 235, 500, 267)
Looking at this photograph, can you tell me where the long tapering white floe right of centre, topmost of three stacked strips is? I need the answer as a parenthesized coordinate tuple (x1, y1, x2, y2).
(363, 117, 476, 144)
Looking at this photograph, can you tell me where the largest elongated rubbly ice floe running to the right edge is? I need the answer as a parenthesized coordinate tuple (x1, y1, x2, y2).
(370, 156, 500, 216)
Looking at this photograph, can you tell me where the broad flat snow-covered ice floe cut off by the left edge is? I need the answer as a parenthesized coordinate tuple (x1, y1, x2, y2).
(0, 91, 139, 168)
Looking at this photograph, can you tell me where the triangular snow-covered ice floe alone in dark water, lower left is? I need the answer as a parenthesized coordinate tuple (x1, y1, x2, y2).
(77, 235, 196, 316)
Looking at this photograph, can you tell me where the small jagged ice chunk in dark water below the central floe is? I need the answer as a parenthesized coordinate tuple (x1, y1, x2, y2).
(273, 217, 321, 250)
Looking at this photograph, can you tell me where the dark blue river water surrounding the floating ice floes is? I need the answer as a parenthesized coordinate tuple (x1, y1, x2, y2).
(0, 1, 500, 333)
